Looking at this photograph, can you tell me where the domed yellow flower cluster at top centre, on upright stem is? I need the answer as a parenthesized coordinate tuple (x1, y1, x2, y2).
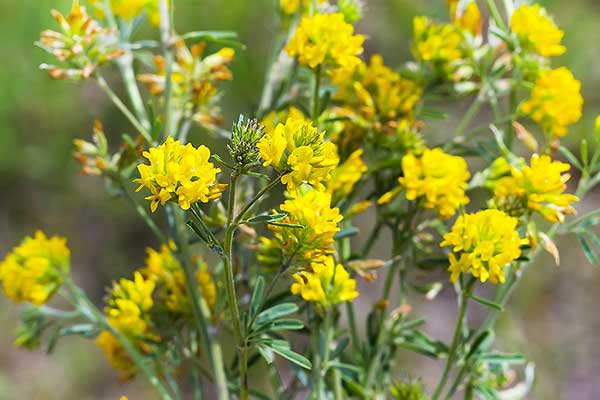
(285, 13, 365, 68)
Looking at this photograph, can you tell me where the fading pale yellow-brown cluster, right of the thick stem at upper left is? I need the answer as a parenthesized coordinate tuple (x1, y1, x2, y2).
(138, 39, 235, 128)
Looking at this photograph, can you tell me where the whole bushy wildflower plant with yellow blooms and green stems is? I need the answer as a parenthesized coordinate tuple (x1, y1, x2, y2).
(0, 0, 600, 400)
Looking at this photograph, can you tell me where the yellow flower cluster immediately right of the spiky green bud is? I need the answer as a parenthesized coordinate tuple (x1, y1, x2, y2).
(258, 118, 339, 192)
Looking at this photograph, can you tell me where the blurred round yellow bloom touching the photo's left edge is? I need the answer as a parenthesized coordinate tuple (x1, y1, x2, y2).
(0, 231, 70, 306)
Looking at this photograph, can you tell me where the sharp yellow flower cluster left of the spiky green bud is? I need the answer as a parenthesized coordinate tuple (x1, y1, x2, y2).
(134, 137, 225, 212)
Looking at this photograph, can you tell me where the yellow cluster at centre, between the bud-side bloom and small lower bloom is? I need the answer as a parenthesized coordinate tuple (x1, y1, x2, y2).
(258, 189, 343, 268)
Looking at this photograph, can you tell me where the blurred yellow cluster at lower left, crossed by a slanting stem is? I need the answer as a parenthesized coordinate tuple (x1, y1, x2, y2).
(96, 272, 156, 373)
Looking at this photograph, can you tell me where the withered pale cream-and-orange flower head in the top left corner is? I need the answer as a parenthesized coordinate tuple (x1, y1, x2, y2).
(37, 0, 124, 79)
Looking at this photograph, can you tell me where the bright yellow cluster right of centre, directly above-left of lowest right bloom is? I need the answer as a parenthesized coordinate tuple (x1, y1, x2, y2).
(398, 148, 471, 218)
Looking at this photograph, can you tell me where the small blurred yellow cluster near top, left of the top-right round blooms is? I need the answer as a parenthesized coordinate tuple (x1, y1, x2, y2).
(413, 16, 463, 64)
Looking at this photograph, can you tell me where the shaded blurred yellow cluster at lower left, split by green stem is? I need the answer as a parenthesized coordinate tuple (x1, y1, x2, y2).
(141, 244, 217, 315)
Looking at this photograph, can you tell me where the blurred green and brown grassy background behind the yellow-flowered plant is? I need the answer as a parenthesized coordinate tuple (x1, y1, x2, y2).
(0, 0, 600, 400)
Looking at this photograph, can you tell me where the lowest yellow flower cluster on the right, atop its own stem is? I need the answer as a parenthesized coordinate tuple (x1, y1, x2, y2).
(440, 210, 521, 284)
